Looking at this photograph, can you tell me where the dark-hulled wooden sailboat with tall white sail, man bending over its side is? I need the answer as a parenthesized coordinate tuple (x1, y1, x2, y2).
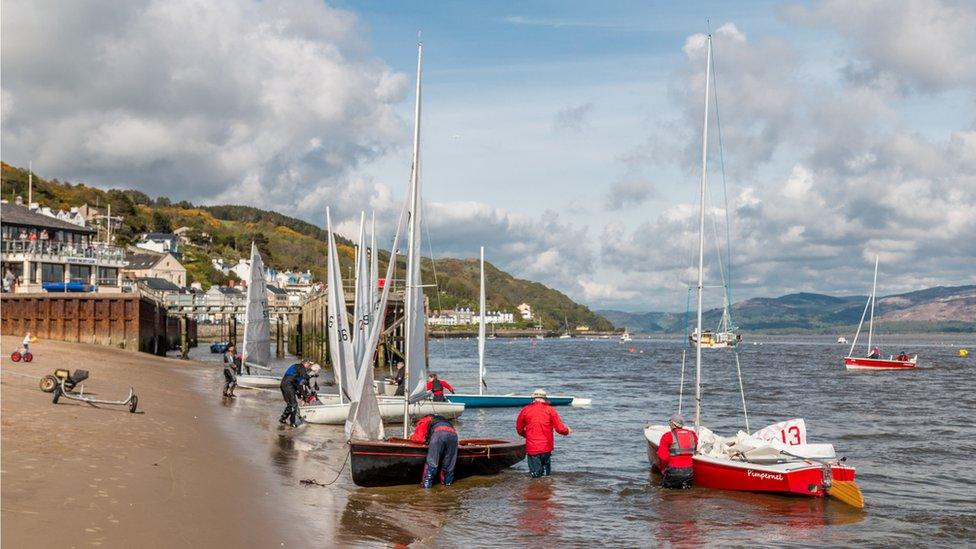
(347, 43, 525, 486)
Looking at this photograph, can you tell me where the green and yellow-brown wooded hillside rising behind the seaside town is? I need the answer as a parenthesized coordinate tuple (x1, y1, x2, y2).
(0, 163, 613, 331)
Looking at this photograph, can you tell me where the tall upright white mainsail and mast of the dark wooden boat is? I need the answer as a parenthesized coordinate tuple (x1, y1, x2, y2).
(404, 40, 427, 395)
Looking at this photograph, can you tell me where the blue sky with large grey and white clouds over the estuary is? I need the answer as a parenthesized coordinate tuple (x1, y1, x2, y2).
(0, 0, 976, 311)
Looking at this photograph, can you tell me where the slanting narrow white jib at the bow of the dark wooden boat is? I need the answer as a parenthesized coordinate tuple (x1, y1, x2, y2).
(346, 211, 403, 440)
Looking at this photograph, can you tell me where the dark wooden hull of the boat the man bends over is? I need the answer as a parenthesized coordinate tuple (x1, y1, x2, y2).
(349, 439, 525, 487)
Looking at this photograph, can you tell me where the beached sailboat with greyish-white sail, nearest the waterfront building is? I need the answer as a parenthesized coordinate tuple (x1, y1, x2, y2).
(237, 242, 281, 388)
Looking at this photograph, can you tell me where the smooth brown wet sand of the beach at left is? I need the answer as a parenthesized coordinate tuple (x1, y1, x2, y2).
(0, 336, 309, 547)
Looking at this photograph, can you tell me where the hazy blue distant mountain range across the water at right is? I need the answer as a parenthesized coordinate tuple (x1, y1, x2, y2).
(597, 286, 976, 334)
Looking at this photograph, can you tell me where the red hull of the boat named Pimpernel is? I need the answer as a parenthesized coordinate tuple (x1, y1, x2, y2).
(647, 432, 855, 497)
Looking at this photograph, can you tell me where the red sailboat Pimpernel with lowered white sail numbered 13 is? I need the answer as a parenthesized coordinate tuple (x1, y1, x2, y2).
(644, 32, 864, 507)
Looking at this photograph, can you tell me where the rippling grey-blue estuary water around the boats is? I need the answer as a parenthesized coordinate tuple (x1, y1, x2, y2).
(183, 336, 976, 547)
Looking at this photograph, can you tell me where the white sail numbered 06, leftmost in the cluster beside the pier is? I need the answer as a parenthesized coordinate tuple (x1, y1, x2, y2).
(325, 208, 356, 401)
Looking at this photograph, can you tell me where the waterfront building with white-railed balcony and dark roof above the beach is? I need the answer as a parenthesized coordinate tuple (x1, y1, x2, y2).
(0, 203, 125, 293)
